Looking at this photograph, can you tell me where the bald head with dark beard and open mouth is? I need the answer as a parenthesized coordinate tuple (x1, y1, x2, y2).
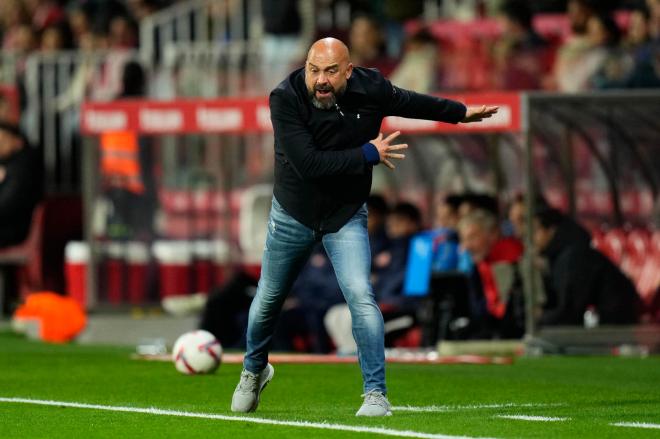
(305, 38, 353, 110)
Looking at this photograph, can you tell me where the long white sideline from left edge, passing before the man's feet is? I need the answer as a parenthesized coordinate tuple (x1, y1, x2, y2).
(0, 397, 492, 439)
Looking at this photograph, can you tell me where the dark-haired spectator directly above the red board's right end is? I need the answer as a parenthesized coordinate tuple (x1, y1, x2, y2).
(493, 0, 550, 90)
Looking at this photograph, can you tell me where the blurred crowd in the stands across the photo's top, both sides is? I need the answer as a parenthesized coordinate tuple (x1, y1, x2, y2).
(0, 0, 660, 92)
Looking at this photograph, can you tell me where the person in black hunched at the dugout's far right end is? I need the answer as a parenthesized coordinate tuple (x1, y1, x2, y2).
(534, 209, 640, 325)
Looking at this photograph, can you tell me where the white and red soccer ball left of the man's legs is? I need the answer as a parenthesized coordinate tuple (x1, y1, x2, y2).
(172, 330, 222, 375)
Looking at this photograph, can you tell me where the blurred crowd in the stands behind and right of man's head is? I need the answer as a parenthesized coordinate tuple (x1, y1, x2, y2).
(264, 0, 660, 92)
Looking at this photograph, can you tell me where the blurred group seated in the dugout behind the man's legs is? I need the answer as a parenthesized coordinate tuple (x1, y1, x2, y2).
(201, 193, 648, 354)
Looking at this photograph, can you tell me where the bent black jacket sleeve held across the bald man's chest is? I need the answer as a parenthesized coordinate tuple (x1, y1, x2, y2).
(270, 89, 367, 179)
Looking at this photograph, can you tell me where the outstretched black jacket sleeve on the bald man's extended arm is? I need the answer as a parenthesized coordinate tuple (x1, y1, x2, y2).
(381, 80, 467, 123)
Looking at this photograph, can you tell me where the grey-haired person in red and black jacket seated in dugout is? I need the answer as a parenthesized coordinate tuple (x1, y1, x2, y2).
(458, 210, 525, 338)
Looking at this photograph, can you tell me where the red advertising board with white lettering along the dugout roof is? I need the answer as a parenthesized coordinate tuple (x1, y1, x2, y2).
(81, 93, 521, 135)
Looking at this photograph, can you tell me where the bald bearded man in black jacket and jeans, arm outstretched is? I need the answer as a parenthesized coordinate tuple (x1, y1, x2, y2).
(231, 38, 497, 416)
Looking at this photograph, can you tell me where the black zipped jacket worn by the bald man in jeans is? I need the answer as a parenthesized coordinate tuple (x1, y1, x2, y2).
(270, 67, 466, 233)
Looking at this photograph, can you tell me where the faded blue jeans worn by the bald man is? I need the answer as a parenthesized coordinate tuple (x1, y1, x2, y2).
(243, 197, 387, 393)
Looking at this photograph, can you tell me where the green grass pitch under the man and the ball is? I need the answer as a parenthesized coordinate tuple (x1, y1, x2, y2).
(0, 333, 660, 439)
